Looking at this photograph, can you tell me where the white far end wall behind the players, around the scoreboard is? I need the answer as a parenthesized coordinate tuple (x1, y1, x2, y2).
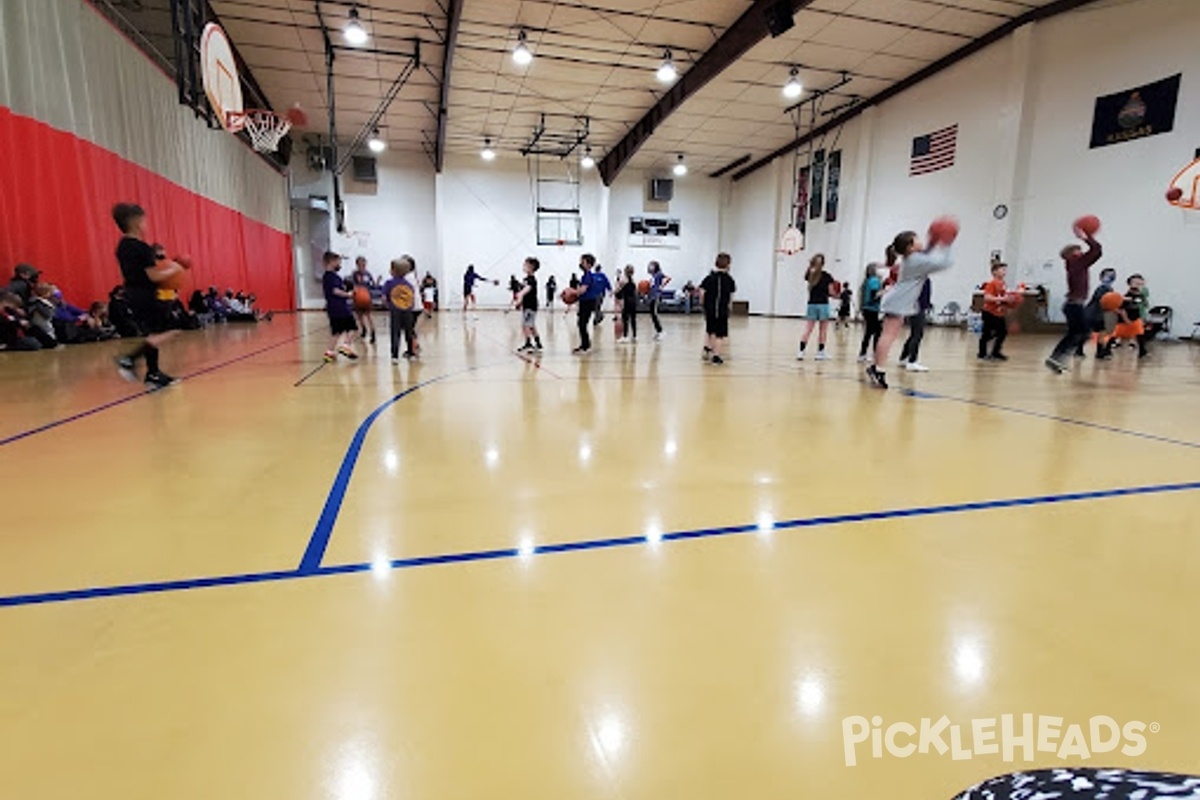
(285, 155, 724, 308)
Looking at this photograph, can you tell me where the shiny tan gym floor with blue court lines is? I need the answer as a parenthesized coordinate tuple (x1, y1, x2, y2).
(0, 312, 1200, 800)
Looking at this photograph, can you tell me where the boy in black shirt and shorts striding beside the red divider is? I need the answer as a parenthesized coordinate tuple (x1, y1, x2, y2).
(113, 203, 185, 389)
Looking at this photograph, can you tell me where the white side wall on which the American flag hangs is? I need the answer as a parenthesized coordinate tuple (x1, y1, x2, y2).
(721, 0, 1200, 332)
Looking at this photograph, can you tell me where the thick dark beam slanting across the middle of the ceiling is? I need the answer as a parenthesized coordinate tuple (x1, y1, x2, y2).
(600, 0, 812, 186)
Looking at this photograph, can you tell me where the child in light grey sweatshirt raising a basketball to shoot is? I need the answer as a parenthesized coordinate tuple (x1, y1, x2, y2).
(866, 219, 958, 389)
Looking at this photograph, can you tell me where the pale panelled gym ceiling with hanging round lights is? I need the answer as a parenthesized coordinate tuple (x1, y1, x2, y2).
(212, 0, 1065, 173)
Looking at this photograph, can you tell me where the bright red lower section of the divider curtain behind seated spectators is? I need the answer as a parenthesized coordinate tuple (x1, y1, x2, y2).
(0, 107, 295, 309)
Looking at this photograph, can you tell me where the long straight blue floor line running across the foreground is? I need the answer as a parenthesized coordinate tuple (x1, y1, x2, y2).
(0, 479, 1200, 608)
